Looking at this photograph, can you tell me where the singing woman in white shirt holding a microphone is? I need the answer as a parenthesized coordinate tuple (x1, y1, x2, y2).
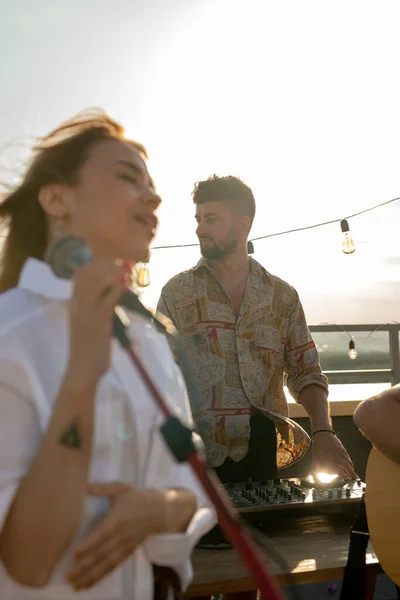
(0, 112, 215, 600)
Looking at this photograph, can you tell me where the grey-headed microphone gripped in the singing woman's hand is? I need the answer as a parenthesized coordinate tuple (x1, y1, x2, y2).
(44, 235, 132, 348)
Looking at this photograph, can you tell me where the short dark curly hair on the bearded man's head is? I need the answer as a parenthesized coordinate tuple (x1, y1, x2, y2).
(192, 175, 256, 226)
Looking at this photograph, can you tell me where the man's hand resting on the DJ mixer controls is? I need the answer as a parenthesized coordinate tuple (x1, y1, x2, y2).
(311, 432, 359, 481)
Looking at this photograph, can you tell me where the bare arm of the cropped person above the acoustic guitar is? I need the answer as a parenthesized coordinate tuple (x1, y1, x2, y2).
(353, 385, 400, 464)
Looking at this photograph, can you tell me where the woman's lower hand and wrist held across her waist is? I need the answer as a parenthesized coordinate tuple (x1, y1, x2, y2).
(66, 483, 196, 590)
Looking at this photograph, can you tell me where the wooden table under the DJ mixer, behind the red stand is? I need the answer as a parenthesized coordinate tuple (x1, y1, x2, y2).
(185, 513, 381, 600)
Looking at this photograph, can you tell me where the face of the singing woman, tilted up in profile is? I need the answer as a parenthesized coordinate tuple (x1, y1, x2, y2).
(63, 140, 161, 262)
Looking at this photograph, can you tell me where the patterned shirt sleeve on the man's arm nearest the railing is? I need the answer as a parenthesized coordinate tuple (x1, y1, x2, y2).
(285, 290, 328, 401)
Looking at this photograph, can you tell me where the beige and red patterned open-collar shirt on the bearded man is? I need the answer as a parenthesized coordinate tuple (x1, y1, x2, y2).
(158, 258, 328, 468)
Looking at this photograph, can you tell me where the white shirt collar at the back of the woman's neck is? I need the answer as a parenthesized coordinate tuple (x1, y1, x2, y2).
(18, 258, 73, 300)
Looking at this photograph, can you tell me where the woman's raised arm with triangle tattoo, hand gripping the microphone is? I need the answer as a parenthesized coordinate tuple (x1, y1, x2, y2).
(0, 259, 125, 587)
